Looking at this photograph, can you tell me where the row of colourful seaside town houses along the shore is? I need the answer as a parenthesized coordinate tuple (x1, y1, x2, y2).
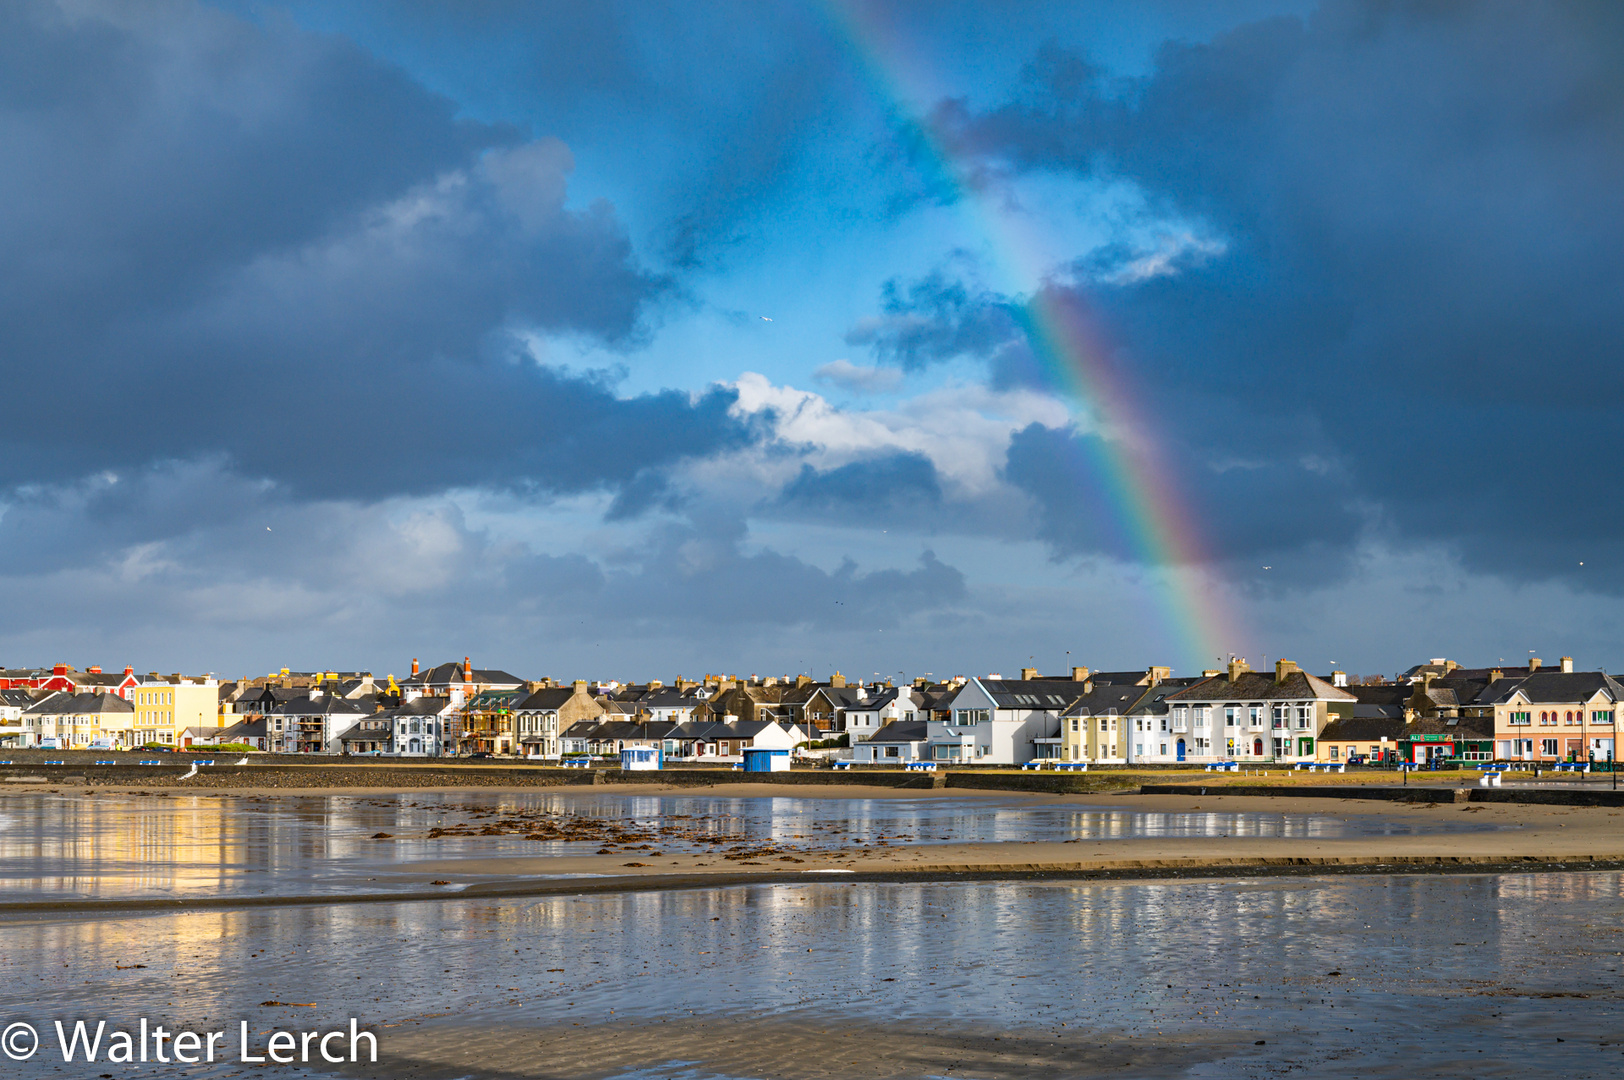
(0, 656, 1624, 770)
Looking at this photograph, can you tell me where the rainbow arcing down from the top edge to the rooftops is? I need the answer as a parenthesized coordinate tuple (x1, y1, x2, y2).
(823, 0, 1247, 669)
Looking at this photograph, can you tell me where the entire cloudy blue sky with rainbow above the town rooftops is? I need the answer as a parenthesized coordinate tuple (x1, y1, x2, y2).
(0, 0, 1624, 679)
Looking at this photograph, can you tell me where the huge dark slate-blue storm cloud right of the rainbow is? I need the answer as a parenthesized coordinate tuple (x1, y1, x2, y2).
(893, 3, 1624, 588)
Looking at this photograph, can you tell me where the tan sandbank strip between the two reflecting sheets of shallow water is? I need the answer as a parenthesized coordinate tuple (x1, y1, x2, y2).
(9, 783, 1624, 911)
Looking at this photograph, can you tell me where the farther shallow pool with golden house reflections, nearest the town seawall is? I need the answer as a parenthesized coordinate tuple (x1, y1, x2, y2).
(0, 791, 1492, 901)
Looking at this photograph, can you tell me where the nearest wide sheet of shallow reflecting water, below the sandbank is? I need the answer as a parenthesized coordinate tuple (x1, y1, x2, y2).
(0, 872, 1624, 1077)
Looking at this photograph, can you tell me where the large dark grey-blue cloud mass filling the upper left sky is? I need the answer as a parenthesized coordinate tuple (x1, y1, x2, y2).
(0, 3, 744, 499)
